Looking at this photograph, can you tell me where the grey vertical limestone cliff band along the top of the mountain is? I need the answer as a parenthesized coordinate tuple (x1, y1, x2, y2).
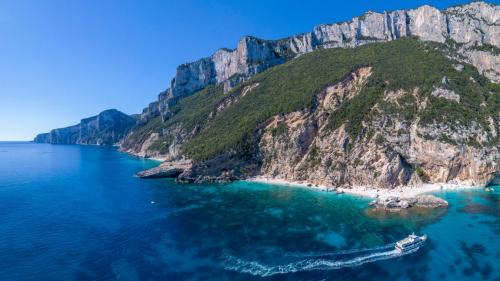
(141, 2, 500, 121)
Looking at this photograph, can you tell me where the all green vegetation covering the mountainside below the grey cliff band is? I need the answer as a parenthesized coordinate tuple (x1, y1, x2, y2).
(135, 38, 500, 159)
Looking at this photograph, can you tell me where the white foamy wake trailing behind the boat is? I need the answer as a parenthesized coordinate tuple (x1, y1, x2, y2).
(223, 244, 420, 277)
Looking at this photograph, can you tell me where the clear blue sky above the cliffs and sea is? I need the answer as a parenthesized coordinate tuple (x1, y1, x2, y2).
(0, 0, 500, 141)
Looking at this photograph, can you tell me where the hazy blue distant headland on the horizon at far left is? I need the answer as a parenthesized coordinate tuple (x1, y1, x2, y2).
(34, 109, 136, 145)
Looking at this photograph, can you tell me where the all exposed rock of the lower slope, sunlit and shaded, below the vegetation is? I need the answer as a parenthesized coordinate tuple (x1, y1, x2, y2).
(131, 61, 500, 188)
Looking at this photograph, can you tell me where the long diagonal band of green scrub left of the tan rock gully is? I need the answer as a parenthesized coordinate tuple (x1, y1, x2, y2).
(184, 39, 382, 159)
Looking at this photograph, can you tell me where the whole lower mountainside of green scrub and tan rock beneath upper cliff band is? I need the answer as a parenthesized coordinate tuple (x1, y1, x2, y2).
(122, 37, 500, 188)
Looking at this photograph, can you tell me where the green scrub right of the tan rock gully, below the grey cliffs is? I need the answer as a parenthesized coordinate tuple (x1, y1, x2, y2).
(329, 39, 500, 145)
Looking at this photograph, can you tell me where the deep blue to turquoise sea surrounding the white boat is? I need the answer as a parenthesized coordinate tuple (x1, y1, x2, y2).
(0, 143, 500, 280)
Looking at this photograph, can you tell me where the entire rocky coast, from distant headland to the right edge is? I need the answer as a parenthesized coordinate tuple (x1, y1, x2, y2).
(36, 2, 500, 188)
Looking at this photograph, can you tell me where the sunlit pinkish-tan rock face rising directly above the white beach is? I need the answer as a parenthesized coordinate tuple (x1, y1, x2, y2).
(258, 68, 500, 188)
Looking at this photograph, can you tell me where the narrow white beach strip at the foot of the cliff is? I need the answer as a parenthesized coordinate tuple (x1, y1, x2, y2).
(245, 176, 481, 198)
